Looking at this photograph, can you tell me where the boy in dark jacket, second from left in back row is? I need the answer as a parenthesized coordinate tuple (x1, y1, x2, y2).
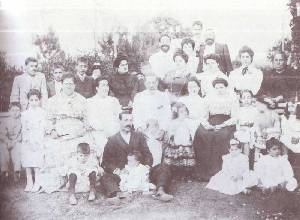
(47, 66, 63, 98)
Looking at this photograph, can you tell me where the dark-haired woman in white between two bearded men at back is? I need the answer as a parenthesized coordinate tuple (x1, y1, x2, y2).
(181, 38, 199, 74)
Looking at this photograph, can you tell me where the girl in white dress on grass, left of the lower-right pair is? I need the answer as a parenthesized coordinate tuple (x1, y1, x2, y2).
(206, 139, 257, 195)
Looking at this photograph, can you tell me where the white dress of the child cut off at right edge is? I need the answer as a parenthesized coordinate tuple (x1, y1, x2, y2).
(280, 115, 300, 153)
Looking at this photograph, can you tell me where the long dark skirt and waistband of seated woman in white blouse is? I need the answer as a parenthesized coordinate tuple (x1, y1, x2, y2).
(193, 115, 235, 180)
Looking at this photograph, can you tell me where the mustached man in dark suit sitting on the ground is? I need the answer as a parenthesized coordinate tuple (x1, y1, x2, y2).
(101, 110, 173, 203)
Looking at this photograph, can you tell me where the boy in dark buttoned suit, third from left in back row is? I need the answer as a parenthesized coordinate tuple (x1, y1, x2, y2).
(75, 57, 95, 98)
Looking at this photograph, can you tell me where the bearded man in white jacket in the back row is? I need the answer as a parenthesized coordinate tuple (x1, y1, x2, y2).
(149, 35, 175, 79)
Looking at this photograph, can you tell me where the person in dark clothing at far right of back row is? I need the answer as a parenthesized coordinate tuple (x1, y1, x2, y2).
(258, 51, 297, 108)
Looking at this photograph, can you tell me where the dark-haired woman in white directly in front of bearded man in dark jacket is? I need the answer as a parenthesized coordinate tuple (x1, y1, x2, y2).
(195, 54, 228, 97)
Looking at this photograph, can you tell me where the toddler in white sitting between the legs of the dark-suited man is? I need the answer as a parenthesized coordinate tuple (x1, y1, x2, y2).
(118, 151, 156, 194)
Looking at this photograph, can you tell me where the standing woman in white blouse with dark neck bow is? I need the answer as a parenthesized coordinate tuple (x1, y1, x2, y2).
(229, 46, 263, 96)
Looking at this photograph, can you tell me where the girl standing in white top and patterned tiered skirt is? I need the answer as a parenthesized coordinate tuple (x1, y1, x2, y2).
(163, 103, 196, 180)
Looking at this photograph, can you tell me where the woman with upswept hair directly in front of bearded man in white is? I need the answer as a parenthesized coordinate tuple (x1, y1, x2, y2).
(159, 49, 191, 102)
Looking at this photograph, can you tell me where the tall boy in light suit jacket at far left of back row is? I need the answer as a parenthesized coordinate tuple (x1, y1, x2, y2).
(10, 57, 48, 111)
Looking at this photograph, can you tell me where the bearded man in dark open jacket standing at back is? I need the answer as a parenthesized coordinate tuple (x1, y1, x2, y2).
(197, 29, 233, 75)
